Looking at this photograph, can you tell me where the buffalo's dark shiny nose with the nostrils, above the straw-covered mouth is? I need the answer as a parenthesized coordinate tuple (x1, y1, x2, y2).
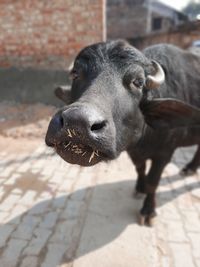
(62, 107, 107, 137)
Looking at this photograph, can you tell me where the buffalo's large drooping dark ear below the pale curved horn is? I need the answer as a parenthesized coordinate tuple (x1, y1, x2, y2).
(140, 98, 200, 128)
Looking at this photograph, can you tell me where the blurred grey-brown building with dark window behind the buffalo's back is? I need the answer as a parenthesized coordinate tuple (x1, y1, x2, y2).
(107, 0, 188, 39)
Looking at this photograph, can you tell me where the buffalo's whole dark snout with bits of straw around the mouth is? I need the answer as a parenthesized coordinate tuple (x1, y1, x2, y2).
(45, 103, 113, 166)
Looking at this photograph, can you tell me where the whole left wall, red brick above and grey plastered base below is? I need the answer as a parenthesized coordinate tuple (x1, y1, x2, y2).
(0, 0, 105, 103)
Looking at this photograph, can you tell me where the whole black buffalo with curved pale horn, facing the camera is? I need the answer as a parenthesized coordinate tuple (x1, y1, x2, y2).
(46, 40, 200, 226)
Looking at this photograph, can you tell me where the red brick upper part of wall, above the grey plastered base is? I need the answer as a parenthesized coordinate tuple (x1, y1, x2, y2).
(0, 0, 105, 69)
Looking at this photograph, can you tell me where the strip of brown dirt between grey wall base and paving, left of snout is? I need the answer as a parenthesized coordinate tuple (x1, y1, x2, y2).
(0, 102, 56, 140)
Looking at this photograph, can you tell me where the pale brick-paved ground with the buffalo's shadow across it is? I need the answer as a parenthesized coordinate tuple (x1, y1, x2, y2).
(0, 104, 200, 267)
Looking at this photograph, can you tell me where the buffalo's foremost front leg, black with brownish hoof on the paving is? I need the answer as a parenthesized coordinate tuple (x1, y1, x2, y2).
(140, 153, 172, 225)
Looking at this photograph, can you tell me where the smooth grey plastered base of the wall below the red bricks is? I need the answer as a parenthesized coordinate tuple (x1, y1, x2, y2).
(0, 67, 69, 105)
